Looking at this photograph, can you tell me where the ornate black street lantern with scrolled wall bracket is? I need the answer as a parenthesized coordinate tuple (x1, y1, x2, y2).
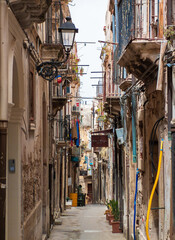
(36, 17, 78, 81)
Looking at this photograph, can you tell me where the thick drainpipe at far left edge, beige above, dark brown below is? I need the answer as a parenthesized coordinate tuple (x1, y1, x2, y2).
(0, 0, 8, 240)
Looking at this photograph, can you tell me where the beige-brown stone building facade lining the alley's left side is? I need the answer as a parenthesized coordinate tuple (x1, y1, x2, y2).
(0, 0, 80, 240)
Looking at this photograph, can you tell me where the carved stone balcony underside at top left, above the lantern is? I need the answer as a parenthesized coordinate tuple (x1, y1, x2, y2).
(9, 0, 52, 29)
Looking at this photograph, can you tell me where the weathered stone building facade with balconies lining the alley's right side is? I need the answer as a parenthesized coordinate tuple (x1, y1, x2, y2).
(100, 0, 175, 239)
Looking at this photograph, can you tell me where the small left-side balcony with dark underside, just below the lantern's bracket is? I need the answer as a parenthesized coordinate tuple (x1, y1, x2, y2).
(52, 80, 67, 116)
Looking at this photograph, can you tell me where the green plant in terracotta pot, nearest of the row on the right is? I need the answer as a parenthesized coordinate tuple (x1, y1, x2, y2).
(111, 200, 122, 233)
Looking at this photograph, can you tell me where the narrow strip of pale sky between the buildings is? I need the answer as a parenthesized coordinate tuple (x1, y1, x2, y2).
(70, 0, 108, 101)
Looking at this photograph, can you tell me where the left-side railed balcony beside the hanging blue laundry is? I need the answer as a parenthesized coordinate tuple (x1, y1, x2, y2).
(54, 116, 70, 147)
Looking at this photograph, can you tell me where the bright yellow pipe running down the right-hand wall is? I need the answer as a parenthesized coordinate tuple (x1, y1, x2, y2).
(146, 139, 163, 240)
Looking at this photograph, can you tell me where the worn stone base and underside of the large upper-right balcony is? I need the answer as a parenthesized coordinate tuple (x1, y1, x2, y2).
(118, 39, 162, 81)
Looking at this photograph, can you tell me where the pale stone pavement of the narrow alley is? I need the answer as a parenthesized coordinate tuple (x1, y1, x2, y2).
(48, 204, 125, 240)
